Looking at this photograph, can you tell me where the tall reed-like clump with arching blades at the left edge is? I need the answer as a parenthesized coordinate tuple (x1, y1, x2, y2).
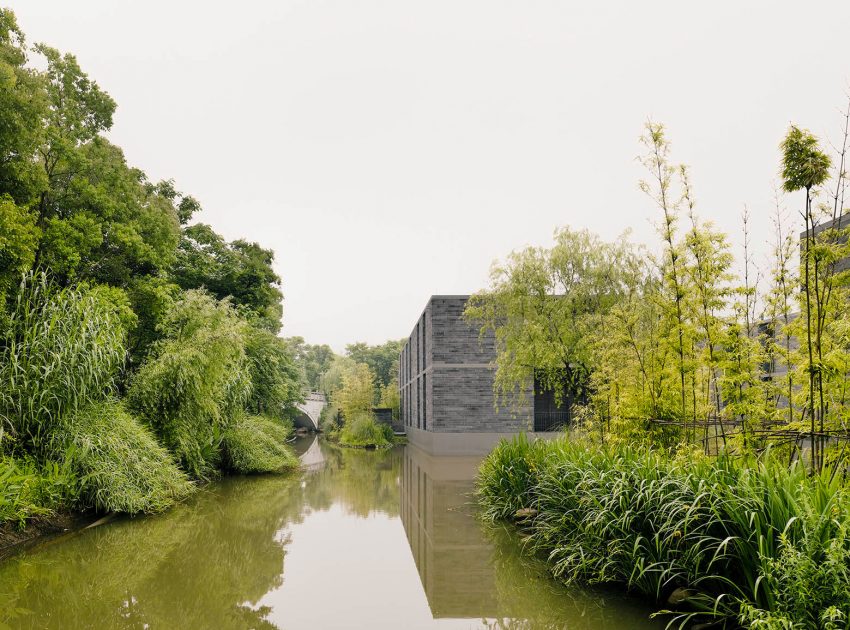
(0, 274, 126, 456)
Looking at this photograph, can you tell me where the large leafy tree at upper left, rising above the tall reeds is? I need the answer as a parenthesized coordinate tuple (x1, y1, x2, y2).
(0, 32, 188, 286)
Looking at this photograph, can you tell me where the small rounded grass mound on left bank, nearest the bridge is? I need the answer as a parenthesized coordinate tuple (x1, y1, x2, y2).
(222, 415, 299, 474)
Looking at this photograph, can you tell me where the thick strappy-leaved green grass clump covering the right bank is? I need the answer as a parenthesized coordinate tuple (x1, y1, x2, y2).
(477, 438, 850, 629)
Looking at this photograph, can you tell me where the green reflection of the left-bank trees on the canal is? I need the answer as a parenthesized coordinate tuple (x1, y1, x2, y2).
(0, 446, 399, 629)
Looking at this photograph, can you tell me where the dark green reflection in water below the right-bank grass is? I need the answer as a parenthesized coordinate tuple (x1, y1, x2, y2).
(482, 525, 664, 630)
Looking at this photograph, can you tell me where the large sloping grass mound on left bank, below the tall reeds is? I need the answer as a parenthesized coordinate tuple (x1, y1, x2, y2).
(66, 400, 193, 514)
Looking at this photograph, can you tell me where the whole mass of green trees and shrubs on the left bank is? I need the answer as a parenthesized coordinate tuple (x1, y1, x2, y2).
(0, 9, 302, 526)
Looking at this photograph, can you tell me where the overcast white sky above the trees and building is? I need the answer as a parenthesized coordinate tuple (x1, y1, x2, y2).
(7, 0, 850, 350)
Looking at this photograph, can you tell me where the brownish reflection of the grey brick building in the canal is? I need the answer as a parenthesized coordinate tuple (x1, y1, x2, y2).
(401, 446, 498, 619)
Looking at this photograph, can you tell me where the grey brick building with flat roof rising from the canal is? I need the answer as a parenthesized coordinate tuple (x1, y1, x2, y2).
(398, 295, 564, 454)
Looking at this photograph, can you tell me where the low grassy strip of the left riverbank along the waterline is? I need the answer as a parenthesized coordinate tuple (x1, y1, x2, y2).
(0, 414, 300, 558)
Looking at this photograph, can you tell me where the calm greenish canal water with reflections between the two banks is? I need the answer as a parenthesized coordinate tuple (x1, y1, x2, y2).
(0, 438, 663, 630)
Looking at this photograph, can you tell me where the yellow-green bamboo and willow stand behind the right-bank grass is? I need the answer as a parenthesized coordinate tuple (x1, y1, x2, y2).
(466, 109, 850, 469)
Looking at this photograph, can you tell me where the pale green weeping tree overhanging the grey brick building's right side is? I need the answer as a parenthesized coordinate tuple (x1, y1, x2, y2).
(466, 229, 636, 414)
